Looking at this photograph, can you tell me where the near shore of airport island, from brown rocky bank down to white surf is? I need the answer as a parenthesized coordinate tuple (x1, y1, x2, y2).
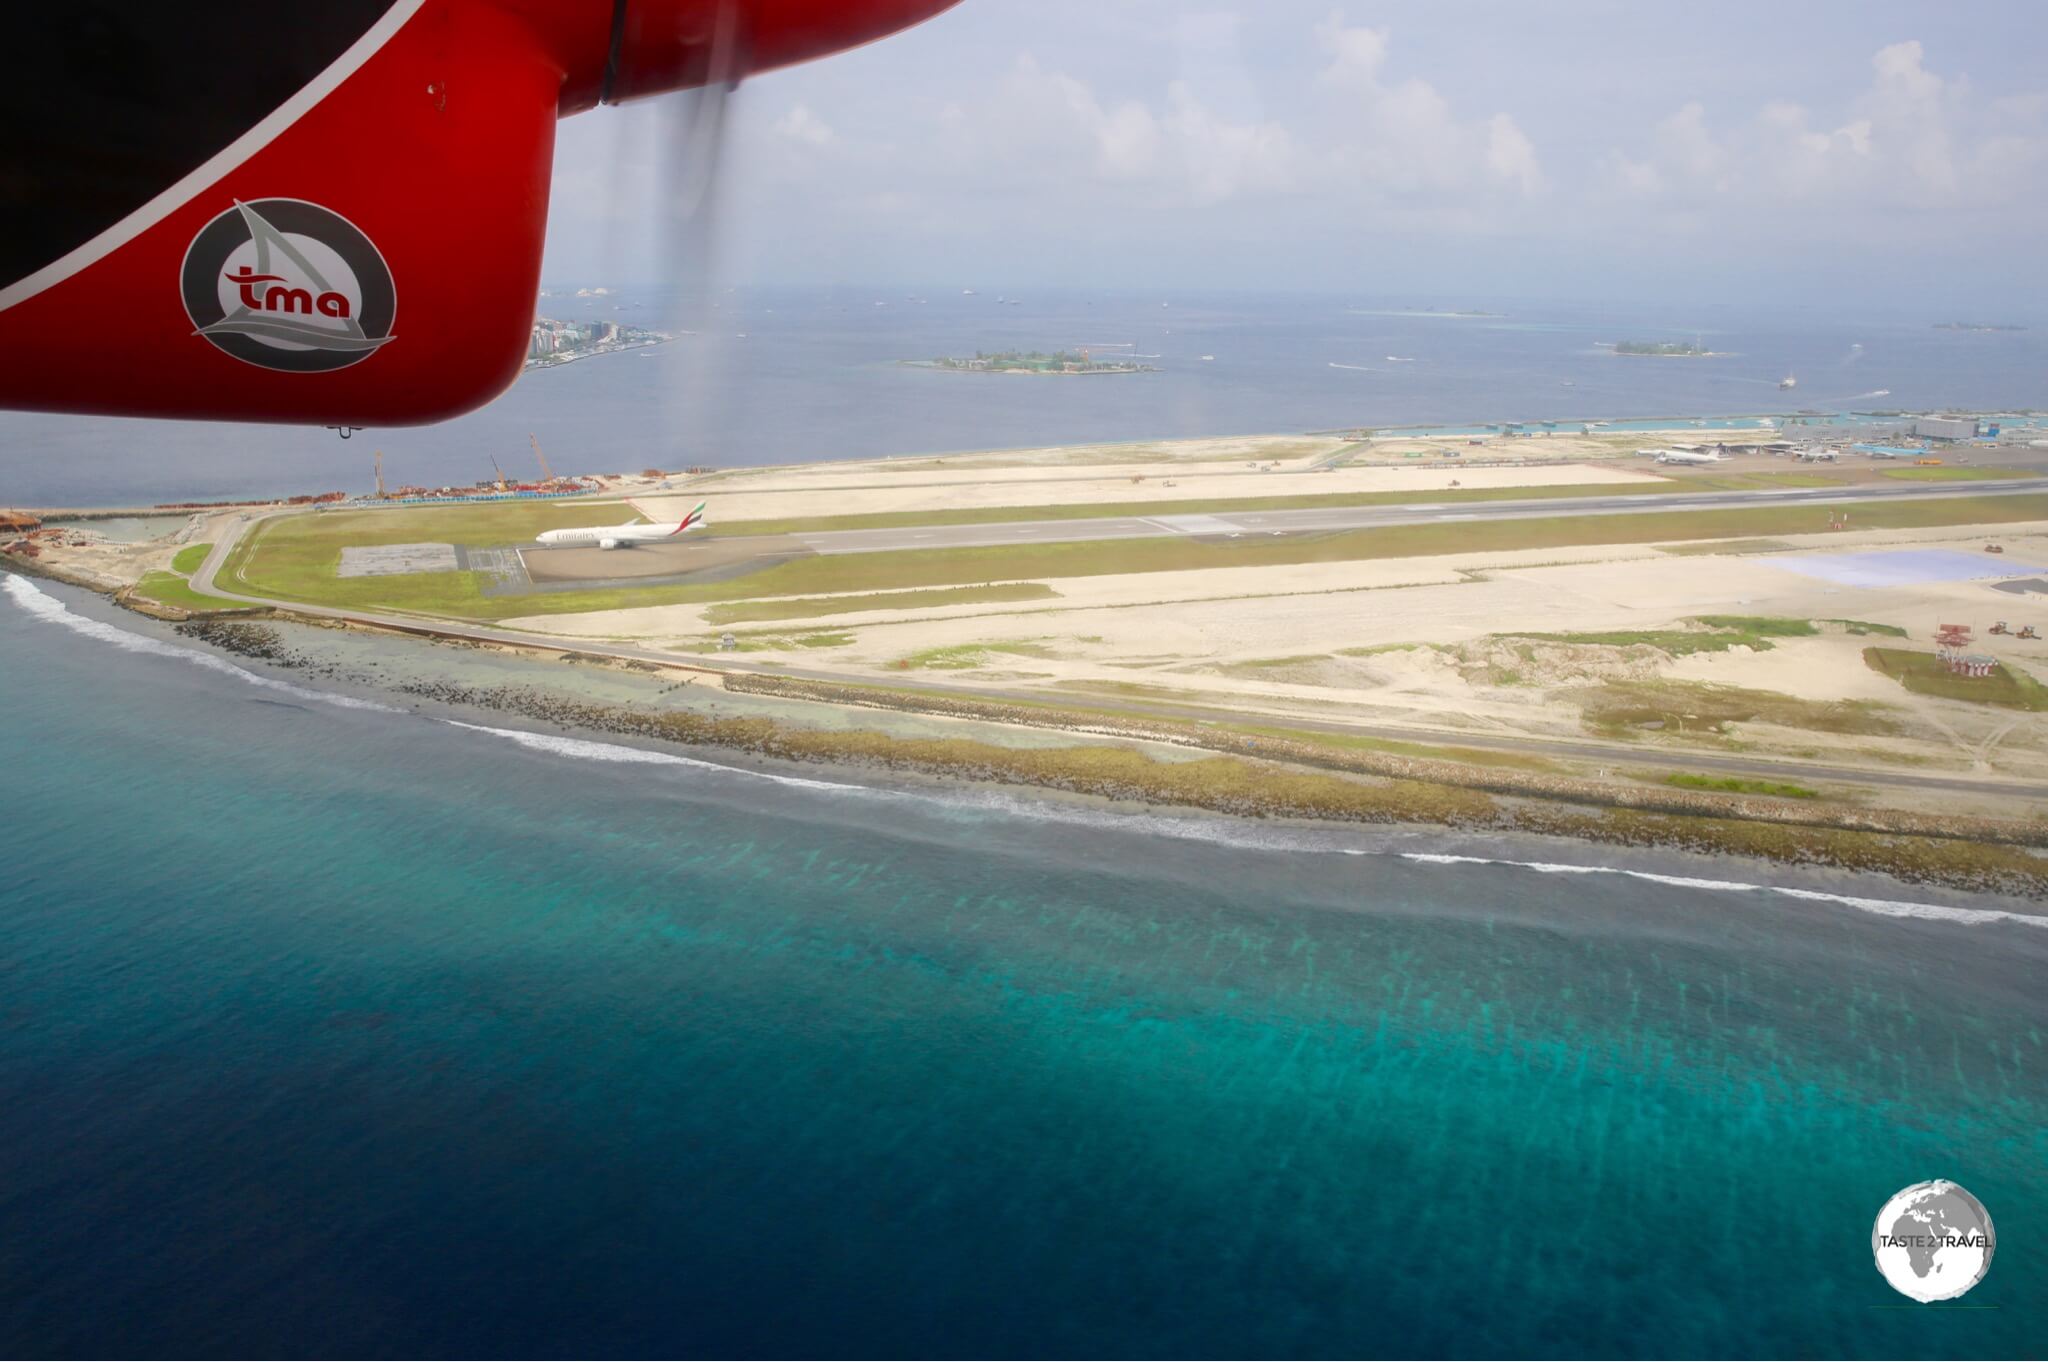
(8, 561, 2048, 922)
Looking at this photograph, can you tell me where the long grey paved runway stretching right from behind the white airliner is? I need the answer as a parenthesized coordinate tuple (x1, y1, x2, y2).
(790, 477, 2048, 553)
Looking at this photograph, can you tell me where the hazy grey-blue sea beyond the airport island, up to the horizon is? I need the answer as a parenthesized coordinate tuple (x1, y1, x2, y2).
(0, 283, 2048, 506)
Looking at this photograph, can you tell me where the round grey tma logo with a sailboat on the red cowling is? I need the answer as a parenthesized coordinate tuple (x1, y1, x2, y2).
(178, 199, 397, 373)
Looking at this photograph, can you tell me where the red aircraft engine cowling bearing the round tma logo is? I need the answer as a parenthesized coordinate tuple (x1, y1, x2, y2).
(0, 0, 954, 426)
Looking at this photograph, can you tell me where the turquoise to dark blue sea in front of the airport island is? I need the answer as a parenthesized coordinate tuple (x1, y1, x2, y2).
(0, 577, 2048, 1358)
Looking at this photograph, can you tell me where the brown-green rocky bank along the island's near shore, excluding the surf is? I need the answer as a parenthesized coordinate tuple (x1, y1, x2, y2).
(99, 589, 2048, 903)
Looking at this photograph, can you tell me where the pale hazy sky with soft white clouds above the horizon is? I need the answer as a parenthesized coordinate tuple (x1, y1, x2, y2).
(547, 0, 2048, 315)
